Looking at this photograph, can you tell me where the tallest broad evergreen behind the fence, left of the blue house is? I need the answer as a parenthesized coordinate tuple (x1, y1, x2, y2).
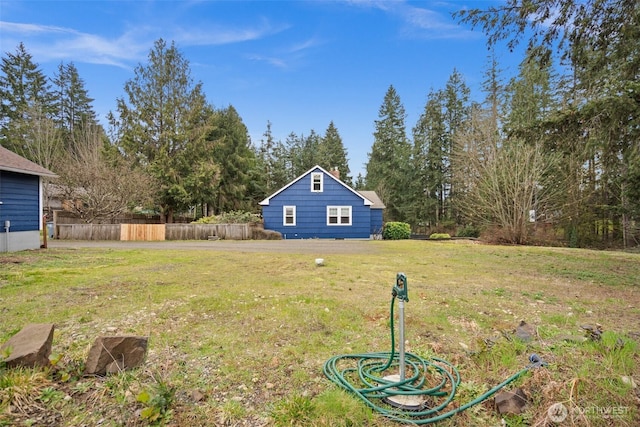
(110, 39, 219, 222)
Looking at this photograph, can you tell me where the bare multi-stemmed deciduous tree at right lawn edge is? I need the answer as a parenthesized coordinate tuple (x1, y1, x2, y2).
(456, 110, 565, 244)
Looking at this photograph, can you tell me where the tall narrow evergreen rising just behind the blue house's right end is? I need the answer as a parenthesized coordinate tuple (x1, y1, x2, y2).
(366, 86, 411, 221)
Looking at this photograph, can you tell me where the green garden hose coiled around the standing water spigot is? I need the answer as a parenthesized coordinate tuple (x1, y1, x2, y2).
(323, 295, 546, 425)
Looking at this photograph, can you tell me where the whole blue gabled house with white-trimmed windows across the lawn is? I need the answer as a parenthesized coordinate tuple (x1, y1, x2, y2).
(260, 166, 384, 239)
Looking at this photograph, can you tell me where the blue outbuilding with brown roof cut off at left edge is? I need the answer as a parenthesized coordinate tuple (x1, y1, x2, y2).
(0, 146, 56, 252)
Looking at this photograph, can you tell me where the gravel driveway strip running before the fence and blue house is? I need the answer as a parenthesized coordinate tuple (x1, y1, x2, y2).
(47, 239, 379, 255)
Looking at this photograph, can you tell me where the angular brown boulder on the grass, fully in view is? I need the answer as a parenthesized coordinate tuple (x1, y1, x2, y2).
(84, 336, 149, 375)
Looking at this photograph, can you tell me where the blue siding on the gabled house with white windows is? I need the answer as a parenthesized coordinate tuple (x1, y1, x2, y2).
(262, 169, 371, 239)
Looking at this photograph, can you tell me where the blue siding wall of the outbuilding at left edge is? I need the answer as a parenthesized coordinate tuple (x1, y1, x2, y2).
(0, 171, 40, 233)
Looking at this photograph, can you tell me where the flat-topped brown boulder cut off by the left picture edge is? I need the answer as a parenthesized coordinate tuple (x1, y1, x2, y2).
(0, 323, 54, 368)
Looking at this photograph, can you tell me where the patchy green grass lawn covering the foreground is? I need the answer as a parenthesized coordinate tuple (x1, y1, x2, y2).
(0, 241, 640, 426)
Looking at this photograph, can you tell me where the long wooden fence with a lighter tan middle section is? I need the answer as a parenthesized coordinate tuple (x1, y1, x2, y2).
(56, 224, 253, 241)
